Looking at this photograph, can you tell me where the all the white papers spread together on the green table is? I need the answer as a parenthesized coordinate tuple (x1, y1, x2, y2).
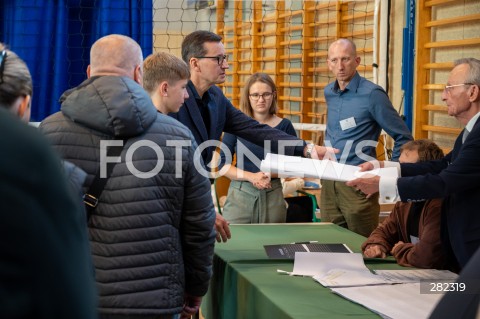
(282, 252, 458, 319)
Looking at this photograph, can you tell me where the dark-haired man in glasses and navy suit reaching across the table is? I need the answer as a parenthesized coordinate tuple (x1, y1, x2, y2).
(169, 30, 340, 242)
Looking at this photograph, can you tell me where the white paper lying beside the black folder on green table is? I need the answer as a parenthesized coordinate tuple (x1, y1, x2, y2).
(291, 252, 388, 287)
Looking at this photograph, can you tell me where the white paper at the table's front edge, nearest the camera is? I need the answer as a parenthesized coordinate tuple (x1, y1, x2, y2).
(332, 283, 443, 319)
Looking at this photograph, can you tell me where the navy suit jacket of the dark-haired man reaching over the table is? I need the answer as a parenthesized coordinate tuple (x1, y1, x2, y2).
(169, 82, 305, 164)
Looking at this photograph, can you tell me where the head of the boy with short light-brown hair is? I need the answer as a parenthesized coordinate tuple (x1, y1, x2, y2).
(143, 52, 190, 114)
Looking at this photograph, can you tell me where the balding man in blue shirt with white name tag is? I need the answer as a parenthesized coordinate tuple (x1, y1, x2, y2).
(321, 39, 413, 236)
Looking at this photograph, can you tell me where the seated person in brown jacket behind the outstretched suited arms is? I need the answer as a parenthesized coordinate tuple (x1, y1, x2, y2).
(362, 140, 448, 269)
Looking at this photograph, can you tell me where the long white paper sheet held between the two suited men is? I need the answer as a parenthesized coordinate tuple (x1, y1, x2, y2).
(260, 153, 398, 182)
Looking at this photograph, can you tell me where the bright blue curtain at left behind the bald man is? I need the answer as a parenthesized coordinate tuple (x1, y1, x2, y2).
(0, 0, 153, 121)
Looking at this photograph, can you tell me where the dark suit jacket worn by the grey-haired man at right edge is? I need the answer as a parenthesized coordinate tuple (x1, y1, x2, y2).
(397, 121, 480, 267)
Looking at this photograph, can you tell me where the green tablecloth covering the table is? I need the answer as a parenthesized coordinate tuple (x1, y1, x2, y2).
(201, 223, 402, 319)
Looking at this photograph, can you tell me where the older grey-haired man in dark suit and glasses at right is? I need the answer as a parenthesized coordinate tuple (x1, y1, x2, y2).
(347, 58, 480, 268)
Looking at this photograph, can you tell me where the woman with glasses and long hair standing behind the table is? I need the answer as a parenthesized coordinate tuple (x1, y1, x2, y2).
(221, 73, 296, 224)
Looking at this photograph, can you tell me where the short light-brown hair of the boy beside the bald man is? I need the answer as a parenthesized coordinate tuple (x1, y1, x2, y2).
(143, 52, 190, 94)
